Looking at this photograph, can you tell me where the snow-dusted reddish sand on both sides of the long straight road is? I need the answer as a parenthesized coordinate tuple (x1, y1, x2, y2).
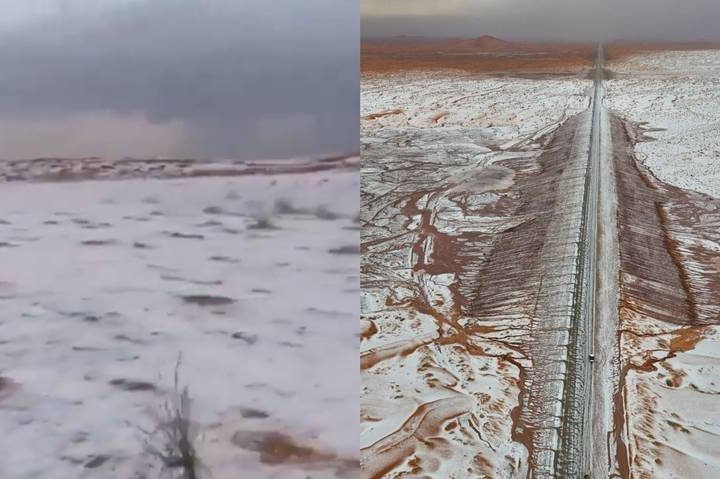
(361, 52, 720, 479)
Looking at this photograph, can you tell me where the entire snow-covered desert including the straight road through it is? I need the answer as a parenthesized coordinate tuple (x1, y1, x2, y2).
(360, 41, 720, 479)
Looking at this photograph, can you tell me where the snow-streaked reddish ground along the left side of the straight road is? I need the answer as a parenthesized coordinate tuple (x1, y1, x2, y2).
(361, 73, 591, 479)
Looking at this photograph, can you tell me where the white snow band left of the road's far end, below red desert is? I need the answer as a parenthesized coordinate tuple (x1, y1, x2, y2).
(360, 73, 591, 148)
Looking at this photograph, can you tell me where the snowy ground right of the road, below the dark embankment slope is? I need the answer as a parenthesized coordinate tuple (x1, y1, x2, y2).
(623, 330, 720, 479)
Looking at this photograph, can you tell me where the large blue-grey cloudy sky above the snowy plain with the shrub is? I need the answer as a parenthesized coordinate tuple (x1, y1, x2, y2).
(0, 0, 360, 159)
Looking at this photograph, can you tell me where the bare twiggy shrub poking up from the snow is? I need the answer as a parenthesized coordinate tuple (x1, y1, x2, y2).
(140, 356, 201, 479)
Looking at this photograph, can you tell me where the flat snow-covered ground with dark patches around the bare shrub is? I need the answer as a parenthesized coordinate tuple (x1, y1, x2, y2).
(0, 167, 359, 479)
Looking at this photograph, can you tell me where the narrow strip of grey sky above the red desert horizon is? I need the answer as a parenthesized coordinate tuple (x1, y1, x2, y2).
(361, 0, 720, 41)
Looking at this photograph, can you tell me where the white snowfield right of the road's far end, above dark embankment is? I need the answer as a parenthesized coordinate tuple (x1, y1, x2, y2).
(606, 50, 720, 198)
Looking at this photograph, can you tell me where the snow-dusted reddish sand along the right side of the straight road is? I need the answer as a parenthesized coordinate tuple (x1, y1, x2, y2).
(606, 50, 720, 478)
